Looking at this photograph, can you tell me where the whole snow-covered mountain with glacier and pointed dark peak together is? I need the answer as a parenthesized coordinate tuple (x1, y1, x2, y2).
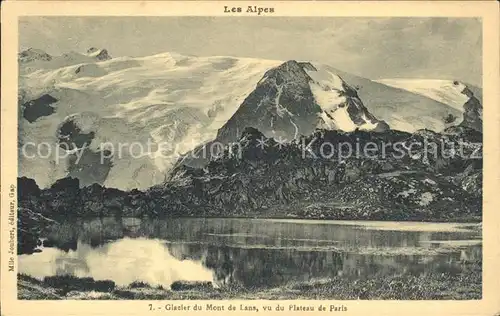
(19, 48, 480, 189)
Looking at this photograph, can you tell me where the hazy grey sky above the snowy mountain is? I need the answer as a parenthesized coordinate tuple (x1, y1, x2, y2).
(19, 17, 482, 86)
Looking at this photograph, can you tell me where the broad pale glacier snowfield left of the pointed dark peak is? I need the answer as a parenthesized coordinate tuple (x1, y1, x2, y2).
(19, 53, 280, 189)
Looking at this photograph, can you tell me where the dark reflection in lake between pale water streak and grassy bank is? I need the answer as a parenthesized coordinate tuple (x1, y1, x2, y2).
(167, 243, 481, 287)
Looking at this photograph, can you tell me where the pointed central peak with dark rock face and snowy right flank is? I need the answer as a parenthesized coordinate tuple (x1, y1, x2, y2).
(217, 60, 388, 142)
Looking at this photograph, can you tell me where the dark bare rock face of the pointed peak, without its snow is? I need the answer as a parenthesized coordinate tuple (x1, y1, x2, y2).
(217, 60, 321, 143)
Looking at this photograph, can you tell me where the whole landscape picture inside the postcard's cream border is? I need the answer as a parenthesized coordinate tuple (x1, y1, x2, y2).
(15, 15, 483, 302)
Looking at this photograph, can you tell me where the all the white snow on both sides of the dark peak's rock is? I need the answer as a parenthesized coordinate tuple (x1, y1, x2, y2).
(19, 49, 480, 189)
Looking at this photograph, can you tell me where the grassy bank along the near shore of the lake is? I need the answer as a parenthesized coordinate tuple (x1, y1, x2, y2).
(18, 261, 482, 300)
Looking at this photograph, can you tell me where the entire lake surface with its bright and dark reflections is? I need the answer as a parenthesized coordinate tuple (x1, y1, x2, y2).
(19, 218, 481, 288)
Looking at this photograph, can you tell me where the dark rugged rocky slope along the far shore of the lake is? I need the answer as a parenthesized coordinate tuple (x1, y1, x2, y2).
(19, 122, 482, 221)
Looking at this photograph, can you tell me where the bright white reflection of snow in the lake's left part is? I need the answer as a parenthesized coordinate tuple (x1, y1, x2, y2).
(18, 238, 213, 288)
